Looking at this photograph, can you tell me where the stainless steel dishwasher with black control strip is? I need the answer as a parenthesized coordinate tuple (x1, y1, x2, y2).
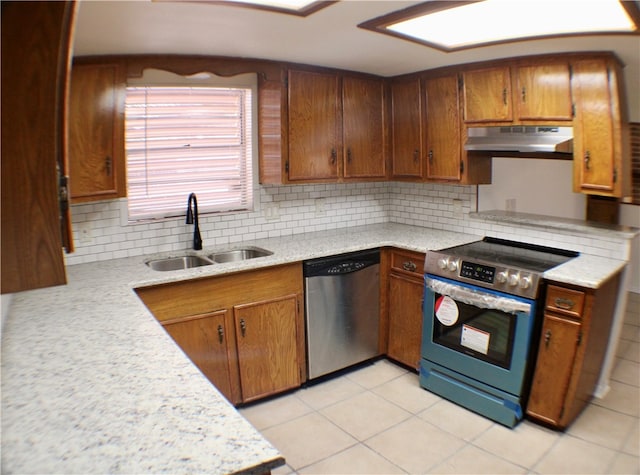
(304, 249, 380, 379)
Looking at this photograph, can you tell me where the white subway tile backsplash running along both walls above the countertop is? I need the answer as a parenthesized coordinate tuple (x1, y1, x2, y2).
(66, 182, 629, 265)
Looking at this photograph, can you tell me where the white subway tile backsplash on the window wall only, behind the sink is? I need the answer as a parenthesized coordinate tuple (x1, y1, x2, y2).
(66, 183, 391, 265)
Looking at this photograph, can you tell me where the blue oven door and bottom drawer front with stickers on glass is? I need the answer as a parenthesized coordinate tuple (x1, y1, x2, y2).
(421, 275, 536, 426)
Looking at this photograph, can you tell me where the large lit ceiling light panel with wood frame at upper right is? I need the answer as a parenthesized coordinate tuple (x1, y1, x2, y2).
(360, 0, 638, 51)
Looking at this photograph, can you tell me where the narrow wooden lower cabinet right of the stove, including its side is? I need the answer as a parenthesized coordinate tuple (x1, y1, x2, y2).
(527, 273, 620, 429)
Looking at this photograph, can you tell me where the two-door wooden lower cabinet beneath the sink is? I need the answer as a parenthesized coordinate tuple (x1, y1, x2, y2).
(136, 263, 306, 404)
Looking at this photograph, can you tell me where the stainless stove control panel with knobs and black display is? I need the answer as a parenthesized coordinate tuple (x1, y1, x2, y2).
(424, 251, 540, 298)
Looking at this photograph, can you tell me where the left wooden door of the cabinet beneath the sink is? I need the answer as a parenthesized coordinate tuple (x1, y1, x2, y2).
(162, 310, 234, 402)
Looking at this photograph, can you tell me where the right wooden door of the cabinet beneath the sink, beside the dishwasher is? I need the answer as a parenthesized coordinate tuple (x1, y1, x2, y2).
(233, 295, 301, 402)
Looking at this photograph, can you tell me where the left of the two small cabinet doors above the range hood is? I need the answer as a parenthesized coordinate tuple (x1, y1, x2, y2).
(463, 67, 513, 123)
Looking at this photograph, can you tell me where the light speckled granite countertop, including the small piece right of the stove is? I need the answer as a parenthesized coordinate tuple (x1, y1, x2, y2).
(2, 224, 625, 474)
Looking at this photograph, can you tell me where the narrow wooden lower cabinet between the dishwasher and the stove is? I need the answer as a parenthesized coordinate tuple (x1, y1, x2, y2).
(387, 249, 424, 369)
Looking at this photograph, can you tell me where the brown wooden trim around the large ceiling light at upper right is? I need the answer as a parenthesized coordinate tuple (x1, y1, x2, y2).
(358, 0, 640, 53)
